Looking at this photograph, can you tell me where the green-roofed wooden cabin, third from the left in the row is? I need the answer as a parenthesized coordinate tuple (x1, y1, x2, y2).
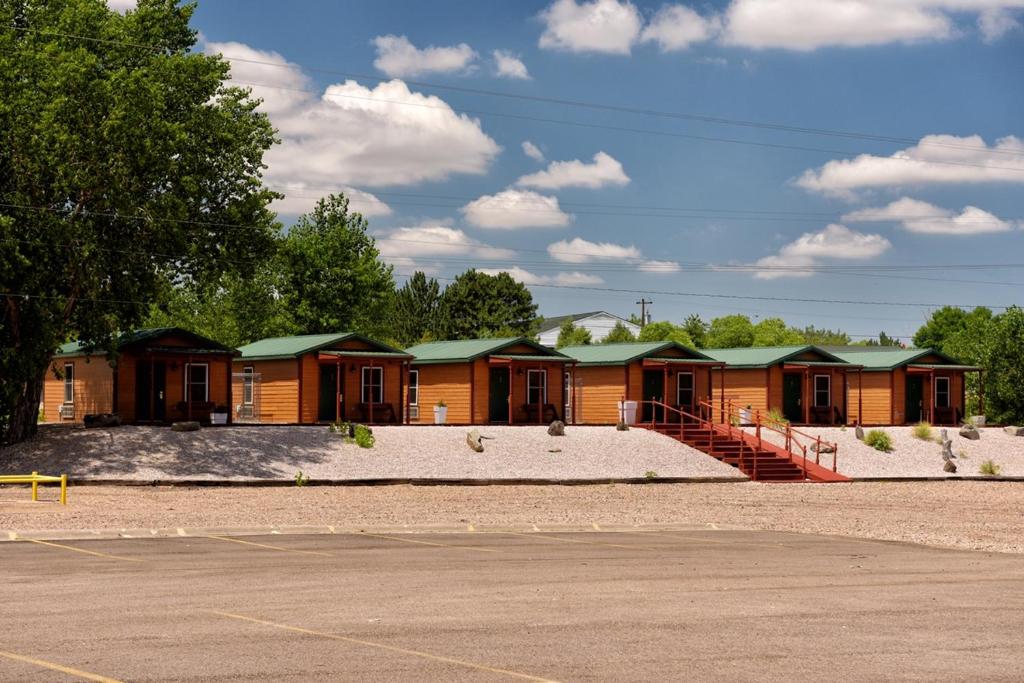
(407, 337, 572, 425)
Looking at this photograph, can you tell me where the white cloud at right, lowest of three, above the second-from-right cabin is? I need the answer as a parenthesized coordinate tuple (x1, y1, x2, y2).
(754, 223, 892, 280)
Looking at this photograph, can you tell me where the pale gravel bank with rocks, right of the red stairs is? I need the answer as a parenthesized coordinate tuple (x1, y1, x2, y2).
(749, 427, 1024, 478)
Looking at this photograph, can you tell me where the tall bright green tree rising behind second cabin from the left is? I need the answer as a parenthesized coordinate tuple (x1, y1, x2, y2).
(278, 195, 394, 336)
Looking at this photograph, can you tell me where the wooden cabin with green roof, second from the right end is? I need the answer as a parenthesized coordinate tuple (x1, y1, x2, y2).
(703, 345, 859, 425)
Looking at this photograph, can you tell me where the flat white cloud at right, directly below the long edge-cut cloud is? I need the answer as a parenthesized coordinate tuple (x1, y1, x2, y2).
(843, 197, 1015, 234)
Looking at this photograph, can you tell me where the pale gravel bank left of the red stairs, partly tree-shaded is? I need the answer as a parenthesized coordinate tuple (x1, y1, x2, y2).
(0, 426, 746, 480)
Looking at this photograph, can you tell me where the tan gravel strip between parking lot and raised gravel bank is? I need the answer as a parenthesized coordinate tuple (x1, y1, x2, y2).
(8, 481, 1024, 553)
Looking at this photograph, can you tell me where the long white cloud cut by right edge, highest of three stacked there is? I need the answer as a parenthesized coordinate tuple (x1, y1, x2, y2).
(797, 135, 1024, 198)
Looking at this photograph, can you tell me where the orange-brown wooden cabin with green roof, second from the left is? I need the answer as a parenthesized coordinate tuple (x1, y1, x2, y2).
(234, 332, 412, 425)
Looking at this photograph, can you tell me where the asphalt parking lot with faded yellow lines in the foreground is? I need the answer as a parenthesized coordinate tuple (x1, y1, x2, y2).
(0, 530, 1024, 681)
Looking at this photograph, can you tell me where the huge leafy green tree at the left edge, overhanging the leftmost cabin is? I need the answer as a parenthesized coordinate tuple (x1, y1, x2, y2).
(0, 0, 278, 442)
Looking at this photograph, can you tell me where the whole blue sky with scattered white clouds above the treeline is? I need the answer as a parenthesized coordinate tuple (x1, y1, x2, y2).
(172, 0, 1024, 342)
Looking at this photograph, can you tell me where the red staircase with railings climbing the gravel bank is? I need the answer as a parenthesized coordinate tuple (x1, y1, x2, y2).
(637, 400, 849, 481)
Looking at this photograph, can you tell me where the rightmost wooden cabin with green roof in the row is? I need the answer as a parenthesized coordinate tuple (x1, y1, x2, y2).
(825, 346, 984, 425)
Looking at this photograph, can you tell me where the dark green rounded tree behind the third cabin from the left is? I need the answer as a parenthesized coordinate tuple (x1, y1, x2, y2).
(437, 269, 539, 339)
